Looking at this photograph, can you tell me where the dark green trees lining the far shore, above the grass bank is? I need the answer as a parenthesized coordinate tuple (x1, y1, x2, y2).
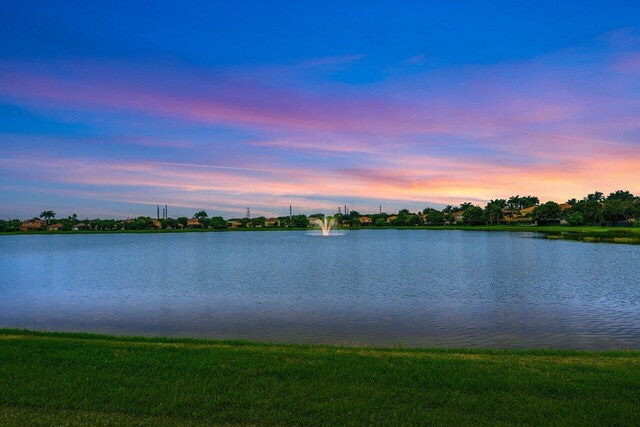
(0, 190, 640, 232)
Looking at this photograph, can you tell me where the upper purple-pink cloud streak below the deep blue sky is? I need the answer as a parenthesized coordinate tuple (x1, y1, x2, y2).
(0, 54, 596, 140)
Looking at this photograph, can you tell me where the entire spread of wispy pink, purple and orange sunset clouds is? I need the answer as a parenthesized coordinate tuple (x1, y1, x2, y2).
(0, 28, 640, 217)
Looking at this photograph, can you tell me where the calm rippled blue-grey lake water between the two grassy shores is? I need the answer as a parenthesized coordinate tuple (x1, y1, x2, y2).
(0, 230, 640, 349)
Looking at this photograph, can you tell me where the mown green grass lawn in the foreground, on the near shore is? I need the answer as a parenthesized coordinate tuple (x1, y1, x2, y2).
(0, 330, 640, 426)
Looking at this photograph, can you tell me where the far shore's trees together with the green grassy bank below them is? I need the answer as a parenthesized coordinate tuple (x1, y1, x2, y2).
(0, 190, 640, 243)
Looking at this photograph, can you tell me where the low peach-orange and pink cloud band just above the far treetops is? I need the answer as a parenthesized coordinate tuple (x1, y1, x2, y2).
(0, 141, 640, 217)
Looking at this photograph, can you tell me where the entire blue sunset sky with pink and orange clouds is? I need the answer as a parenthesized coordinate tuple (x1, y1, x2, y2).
(0, 0, 640, 219)
